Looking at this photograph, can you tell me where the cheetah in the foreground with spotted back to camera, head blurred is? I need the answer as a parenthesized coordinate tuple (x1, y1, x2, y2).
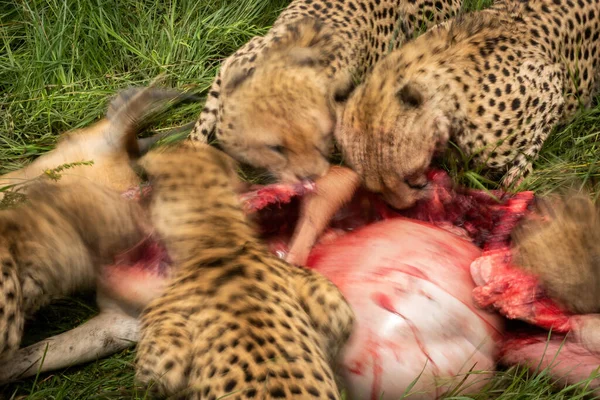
(136, 141, 354, 399)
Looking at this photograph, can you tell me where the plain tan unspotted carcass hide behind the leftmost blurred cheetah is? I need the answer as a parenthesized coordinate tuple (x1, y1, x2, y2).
(0, 87, 191, 200)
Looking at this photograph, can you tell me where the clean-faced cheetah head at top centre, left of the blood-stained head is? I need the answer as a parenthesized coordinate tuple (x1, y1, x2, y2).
(216, 17, 352, 183)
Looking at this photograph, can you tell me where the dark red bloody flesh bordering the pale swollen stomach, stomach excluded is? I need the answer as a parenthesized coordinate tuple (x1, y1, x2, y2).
(241, 171, 600, 394)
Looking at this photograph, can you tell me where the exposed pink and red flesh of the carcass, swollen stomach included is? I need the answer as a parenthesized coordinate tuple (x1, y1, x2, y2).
(107, 166, 600, 398)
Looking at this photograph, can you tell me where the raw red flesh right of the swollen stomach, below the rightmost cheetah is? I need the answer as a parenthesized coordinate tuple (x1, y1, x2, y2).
(471, 233, 600, 395)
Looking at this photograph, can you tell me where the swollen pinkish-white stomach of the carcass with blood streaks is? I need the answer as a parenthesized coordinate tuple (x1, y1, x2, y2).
(309, 218, 503, 399)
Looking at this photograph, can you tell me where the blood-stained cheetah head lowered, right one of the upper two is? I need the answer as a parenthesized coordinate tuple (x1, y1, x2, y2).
(336, 59, 450, 209)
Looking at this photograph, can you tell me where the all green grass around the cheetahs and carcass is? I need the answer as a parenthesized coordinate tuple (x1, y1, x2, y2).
(0, 0, 600, 399)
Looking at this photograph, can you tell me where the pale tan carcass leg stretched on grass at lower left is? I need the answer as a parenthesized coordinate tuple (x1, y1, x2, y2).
(0, 311, 139, 384)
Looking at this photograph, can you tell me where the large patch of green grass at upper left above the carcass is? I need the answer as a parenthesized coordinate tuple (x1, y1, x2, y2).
(0, 0, 287, 173)
